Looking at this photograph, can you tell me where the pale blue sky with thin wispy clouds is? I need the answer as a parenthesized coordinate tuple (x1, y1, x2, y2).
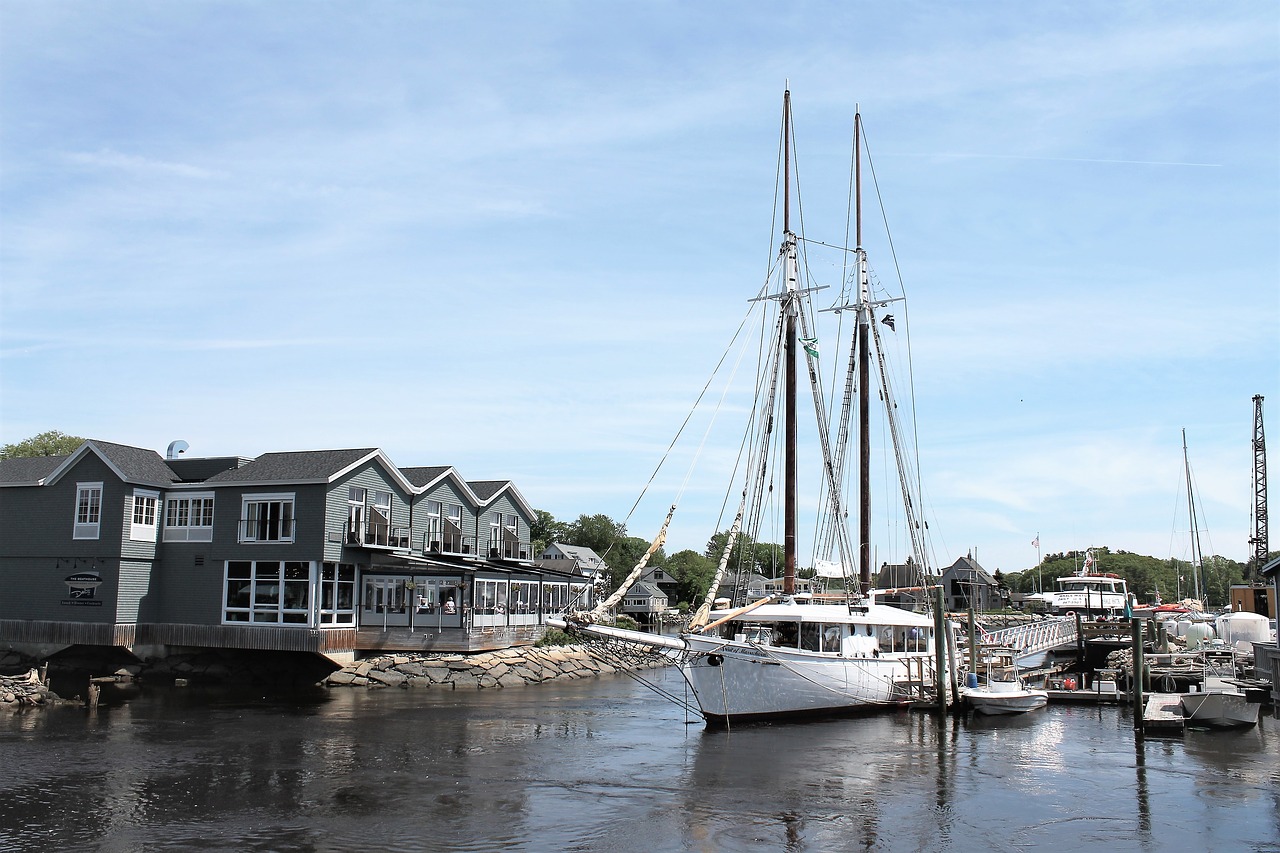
(0, 0, 1280, 571)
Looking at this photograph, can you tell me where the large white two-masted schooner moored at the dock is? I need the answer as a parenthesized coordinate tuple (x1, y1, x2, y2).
(552, 91, 954, 724)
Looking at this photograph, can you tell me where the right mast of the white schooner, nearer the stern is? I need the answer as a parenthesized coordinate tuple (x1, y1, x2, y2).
(854, 111, 872, 594)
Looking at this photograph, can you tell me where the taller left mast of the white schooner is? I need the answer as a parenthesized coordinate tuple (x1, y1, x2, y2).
(782, 88, 799, 596)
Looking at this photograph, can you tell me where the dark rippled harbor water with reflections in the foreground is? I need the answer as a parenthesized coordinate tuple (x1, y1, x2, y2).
(0, 670, 1280, 853)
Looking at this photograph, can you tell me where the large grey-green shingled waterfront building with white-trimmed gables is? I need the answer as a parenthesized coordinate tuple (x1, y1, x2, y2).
(0, 441, 590, 661)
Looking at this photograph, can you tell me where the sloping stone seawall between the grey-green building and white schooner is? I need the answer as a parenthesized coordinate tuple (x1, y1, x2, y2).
(324, 646, 672, 690)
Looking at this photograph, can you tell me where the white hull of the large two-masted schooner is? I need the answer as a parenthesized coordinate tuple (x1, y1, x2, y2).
(681, 634, 920, 722)
